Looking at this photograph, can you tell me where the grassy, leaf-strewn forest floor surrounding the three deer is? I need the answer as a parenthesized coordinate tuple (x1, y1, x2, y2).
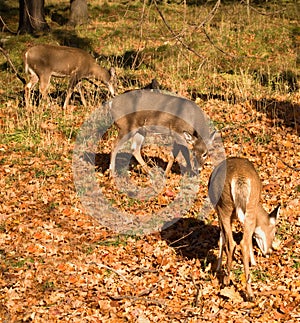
(0, 0, 300, 323)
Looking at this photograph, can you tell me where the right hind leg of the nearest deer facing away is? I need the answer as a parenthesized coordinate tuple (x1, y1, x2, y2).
(241, 214, 255, 301)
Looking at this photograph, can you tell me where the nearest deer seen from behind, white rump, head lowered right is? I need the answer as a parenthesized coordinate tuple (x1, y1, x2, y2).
(209, 157, 279, 300)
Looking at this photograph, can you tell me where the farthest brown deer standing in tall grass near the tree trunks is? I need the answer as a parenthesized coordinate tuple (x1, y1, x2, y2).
(24, 44, 116, 109)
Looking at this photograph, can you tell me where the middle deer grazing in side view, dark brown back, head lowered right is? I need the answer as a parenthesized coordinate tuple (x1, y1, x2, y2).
(108, 90, 215, 175)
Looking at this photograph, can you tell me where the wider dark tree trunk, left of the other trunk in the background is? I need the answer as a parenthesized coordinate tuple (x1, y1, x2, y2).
(18, 0, 50, 34)
